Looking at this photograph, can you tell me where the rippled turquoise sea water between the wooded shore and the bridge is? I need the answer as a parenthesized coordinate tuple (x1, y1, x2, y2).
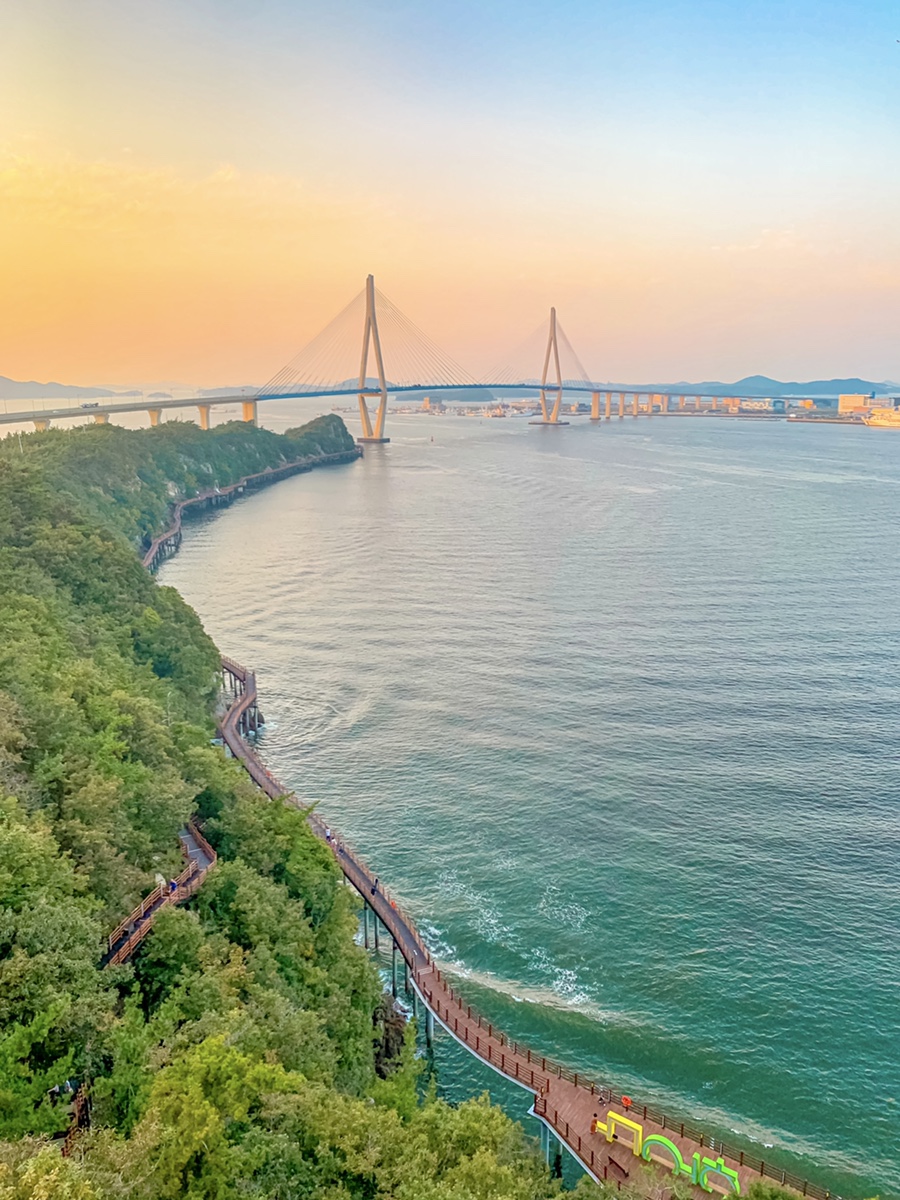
(161, 410, 900, 1196)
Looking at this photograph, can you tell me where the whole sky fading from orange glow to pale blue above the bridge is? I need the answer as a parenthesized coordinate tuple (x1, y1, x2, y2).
(0, 0, 900, 386)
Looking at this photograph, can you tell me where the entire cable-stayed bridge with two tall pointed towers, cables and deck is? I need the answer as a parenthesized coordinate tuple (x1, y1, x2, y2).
(0, 275, 777, 443)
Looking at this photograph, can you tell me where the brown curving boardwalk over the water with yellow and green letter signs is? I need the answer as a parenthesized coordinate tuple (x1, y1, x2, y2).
(220, 658, 836, 1200)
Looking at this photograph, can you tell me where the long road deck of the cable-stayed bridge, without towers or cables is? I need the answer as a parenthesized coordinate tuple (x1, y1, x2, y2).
(0, 380, 796, 430)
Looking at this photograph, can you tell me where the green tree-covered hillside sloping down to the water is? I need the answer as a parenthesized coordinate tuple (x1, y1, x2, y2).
(0, 416, 557, 1200)
